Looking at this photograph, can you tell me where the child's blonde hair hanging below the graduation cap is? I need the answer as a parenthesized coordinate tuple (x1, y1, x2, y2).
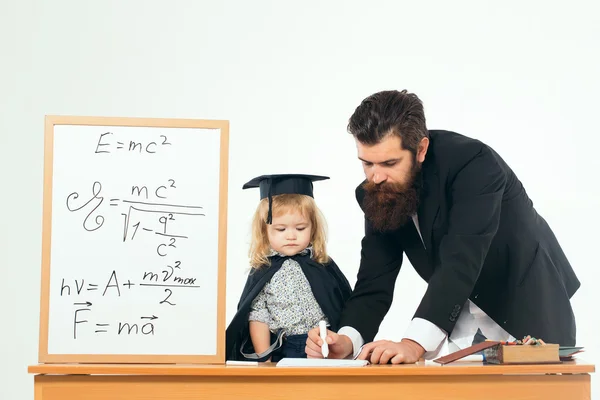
(249, 194, 329, 268)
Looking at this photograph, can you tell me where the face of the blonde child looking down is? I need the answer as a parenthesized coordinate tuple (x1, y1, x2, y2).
(267, 211, 312, 256)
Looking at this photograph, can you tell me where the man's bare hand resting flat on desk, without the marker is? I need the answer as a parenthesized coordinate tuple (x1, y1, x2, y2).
(358, 339, 425, 364)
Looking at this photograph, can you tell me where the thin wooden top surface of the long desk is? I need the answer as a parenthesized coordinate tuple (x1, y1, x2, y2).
(28, 360, 595, 376)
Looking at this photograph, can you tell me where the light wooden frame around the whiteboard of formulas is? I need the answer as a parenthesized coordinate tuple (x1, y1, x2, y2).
(38, 115, 229, 364)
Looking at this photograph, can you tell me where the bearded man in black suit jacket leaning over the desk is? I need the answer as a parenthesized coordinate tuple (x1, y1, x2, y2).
(306, 91, 580, 364)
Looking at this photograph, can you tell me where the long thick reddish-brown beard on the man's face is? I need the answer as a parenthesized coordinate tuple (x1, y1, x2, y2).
(363, 160, 422, 232)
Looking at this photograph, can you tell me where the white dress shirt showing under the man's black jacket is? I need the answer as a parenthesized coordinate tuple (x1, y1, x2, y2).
(338, 215, 515, 360)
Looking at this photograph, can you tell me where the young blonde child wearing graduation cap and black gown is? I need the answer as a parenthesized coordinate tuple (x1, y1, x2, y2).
(226, 174, 352, 362)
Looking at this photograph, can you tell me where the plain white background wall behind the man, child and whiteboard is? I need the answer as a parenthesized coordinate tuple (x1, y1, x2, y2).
(0, 0, 600, 400)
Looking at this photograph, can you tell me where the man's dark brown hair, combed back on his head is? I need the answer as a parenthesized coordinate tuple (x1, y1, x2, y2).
(348, 90, 429, 155)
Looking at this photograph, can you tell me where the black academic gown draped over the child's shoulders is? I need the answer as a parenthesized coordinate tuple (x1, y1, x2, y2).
(225, 254, 352, 361)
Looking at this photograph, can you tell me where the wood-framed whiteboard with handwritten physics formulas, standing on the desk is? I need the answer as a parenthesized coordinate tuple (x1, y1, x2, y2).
(40, 117, 228, 362)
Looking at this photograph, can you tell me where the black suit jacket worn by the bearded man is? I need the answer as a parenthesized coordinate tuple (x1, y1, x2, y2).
(340, 131, 580, 346)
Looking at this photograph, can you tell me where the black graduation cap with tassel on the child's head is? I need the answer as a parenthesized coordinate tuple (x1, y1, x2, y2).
(242, 174, 329, 224)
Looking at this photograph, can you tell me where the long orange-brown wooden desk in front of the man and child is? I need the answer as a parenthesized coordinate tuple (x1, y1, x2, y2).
(28, 360, 595, 400)
